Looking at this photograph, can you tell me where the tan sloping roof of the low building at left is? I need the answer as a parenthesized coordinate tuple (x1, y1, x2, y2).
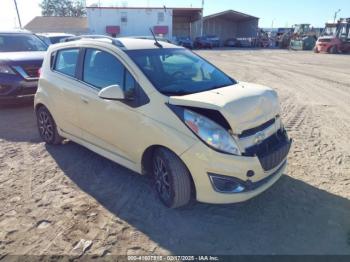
(24, 16, 89, 33)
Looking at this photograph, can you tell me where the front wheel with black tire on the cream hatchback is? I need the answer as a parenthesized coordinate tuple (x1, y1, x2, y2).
(152, 148, 191, 208)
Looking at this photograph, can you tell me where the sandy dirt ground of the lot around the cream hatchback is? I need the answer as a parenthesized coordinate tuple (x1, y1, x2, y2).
(0, 50, 350, 260)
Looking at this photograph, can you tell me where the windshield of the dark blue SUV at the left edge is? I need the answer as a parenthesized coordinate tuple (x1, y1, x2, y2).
(0, 34, 47, 52)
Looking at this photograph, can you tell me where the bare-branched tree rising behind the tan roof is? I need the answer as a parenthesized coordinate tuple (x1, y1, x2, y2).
(39, 0, 86, 17)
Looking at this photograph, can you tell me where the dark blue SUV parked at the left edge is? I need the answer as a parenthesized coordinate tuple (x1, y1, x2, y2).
(0, 30, 47, 104)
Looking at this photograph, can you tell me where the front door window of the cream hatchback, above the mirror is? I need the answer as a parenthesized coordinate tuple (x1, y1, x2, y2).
(83, 49, 124, 89)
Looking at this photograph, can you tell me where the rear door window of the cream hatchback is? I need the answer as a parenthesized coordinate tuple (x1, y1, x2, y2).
(54, 49, 79, 77)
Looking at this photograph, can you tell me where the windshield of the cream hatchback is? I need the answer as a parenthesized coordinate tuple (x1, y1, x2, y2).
(126, 48, 236, 95)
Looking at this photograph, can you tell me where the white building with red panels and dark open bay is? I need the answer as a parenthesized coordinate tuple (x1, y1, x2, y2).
(87, 7, 202, 39)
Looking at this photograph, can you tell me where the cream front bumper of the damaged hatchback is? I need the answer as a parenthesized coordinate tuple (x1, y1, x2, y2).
(181, 132, 292, 204)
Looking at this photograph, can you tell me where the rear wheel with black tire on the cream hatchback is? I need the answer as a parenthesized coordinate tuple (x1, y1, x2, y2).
(36, 106, 63, 145)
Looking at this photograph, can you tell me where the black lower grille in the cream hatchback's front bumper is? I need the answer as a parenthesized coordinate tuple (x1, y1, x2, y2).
(244, 131, 292, 171)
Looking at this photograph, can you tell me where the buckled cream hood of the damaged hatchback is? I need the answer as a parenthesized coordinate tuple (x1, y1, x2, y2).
(169, 82, 280, 134)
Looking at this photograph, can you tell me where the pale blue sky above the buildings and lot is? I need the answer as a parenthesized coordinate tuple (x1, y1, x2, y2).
(0, 0, 350, 28)
